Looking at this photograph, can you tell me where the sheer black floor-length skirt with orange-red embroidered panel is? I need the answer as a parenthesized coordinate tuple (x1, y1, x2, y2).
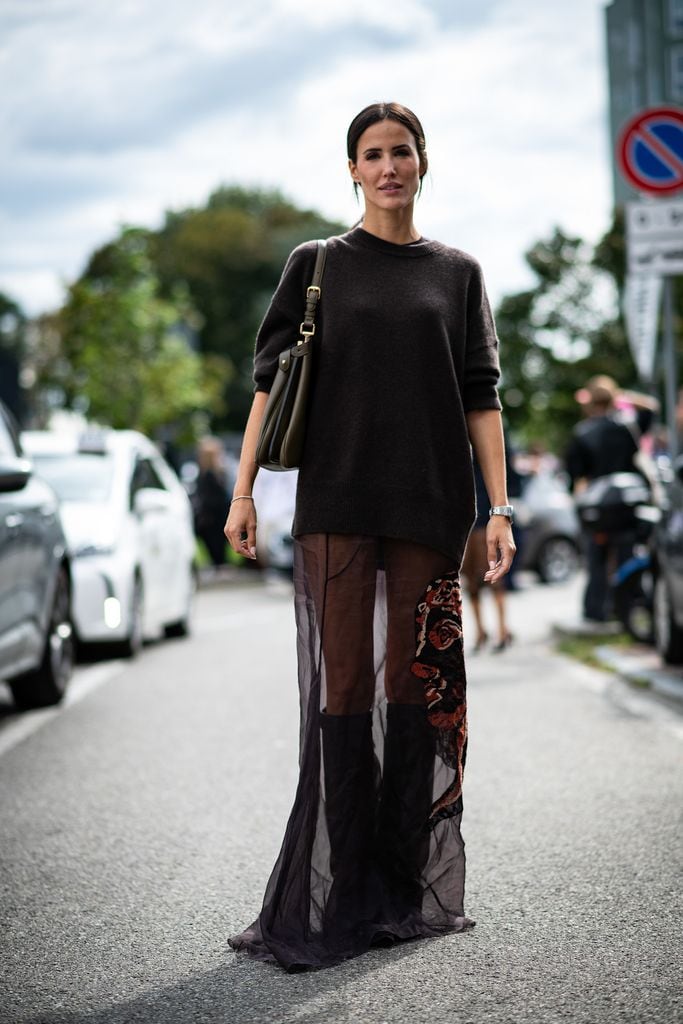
(228, 534, 473, 970)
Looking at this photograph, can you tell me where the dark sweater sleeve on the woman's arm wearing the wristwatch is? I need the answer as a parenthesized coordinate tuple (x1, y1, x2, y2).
(463, 263, 502, 413)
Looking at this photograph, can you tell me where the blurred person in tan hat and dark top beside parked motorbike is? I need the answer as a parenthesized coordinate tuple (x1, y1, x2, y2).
(566, 375, 656, 623)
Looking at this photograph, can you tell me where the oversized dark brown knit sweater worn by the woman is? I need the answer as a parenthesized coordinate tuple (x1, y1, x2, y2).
(254, 227, 501, 567)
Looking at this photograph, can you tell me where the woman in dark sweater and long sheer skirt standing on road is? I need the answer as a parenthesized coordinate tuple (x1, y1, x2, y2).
(225, 103, 514, 970)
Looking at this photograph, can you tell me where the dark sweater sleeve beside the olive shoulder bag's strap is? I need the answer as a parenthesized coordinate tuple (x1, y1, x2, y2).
(254, 242, 317, 391)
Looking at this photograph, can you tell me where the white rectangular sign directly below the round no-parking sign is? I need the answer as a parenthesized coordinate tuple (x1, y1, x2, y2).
(626, 199, 683, 275)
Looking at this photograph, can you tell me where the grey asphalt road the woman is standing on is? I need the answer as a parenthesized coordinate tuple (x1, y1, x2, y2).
(0, 585, 683, 1024)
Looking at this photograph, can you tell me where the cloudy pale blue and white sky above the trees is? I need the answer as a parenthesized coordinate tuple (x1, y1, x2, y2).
(0, 0, 611, 313)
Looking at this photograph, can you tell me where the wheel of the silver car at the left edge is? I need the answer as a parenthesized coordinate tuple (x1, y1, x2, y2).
(9, 565, 75, 708)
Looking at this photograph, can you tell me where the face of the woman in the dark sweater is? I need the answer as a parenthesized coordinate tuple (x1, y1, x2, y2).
(348, 118, 422, 210)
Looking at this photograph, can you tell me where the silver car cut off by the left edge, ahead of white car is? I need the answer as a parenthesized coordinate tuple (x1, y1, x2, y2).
(0, 404, 74, 708)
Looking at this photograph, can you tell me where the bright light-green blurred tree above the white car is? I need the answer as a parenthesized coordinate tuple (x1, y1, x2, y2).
(33, 228, 229, 437)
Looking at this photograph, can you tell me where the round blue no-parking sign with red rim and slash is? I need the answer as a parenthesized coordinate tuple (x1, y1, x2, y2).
(616, 106, 683, 196)
